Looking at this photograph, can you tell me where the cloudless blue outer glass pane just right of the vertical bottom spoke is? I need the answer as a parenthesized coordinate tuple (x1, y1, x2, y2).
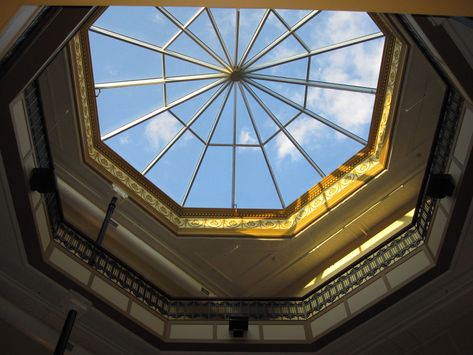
(235, 147, 282, 209)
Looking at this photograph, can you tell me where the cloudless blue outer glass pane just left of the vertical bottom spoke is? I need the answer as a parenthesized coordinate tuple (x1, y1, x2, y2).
(185, 147, 232, 208)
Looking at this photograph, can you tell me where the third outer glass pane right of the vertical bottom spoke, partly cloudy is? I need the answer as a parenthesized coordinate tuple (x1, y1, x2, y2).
(287, 114, 363, 175)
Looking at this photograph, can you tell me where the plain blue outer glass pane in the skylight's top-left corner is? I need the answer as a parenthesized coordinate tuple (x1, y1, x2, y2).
(94, 6, 178, 46)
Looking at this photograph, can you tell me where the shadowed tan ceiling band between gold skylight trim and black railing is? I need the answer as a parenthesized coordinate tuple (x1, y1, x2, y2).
(40, 13, 445, 297)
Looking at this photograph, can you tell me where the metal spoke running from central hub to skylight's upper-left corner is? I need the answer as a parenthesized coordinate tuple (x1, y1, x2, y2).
(89, 26, 229, 73)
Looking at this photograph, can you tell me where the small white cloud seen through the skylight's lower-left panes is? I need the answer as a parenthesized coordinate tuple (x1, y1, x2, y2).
(145, 112, 181, 150)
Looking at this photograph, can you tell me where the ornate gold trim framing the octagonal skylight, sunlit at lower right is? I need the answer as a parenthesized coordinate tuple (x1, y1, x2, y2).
(70, 11, 407, 237)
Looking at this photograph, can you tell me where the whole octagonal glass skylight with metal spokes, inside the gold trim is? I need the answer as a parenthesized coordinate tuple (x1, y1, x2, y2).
(89, 7, 384, 209)
